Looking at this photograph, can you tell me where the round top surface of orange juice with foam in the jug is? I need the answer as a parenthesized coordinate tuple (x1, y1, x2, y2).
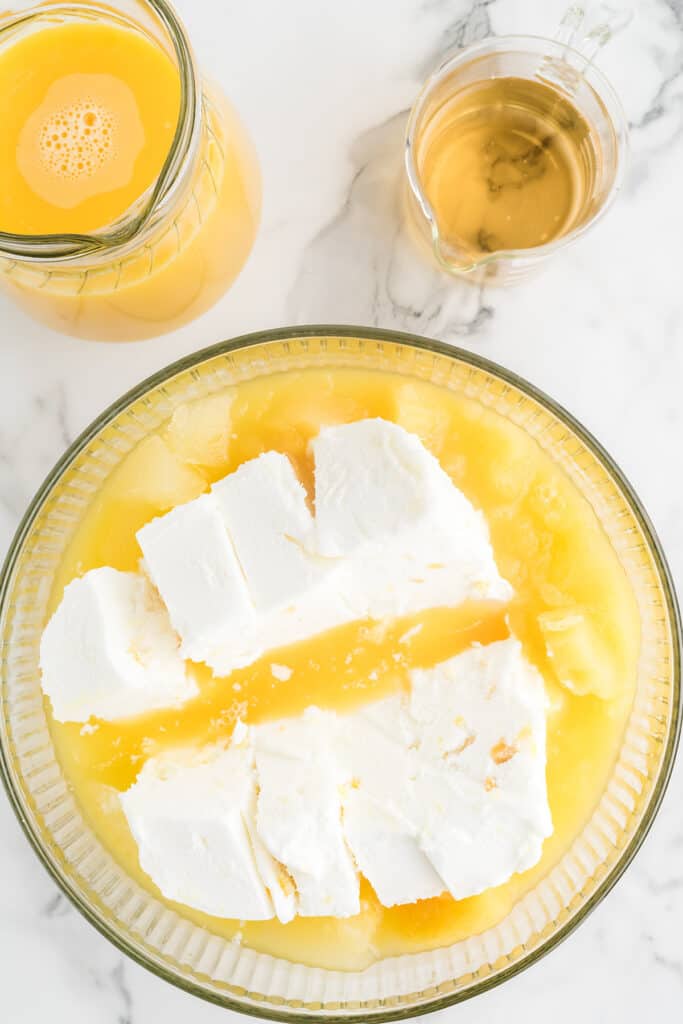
(0, 22, 180, 234)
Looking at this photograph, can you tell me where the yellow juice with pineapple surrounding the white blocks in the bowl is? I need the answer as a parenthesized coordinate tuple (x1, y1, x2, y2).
(51, 369, 639, 970)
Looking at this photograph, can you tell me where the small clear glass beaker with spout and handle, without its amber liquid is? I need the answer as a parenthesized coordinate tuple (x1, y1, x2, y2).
(404, 7, 630, 284)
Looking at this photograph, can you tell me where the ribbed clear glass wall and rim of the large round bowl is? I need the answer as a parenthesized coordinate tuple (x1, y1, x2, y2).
(0, 327, 681, 1021)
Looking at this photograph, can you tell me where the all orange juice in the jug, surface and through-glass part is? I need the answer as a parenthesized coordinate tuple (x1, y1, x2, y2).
(0, 20, 260, 341)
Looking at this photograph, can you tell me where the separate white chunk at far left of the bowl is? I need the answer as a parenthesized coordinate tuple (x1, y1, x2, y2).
(40, 568, 198, 722)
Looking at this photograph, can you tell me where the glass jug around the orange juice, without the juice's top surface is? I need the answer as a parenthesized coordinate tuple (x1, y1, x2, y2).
(0, 0, 260, 341)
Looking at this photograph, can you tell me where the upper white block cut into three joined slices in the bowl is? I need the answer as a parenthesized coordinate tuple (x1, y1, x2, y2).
(133, 420, 512, 675)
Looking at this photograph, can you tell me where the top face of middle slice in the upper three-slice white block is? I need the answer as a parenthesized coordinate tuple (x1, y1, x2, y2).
(212, 452, 322, 610)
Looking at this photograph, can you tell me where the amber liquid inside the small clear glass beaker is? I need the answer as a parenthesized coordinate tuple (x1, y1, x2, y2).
(417, 78, 597, 253)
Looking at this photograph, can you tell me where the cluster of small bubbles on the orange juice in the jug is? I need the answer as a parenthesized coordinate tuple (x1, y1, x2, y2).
(38, 99, 116, 178)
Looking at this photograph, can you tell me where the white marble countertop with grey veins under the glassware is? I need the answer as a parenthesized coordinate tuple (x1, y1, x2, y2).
(0, 0, 683, 1024)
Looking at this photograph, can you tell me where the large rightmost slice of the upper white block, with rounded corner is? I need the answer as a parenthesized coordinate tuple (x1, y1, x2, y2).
(311, 420, 512, 617)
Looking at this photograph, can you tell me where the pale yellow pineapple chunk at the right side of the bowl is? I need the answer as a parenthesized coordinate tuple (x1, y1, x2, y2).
(539, 607, 620, 700)
